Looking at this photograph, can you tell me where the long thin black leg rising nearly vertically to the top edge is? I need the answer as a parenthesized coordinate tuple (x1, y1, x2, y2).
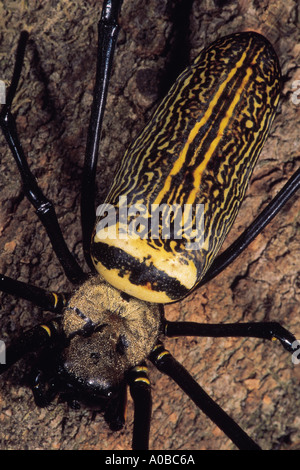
(81, 0, 123, 270)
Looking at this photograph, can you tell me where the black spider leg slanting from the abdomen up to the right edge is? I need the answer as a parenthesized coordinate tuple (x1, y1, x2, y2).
(196, 168, 300, 289)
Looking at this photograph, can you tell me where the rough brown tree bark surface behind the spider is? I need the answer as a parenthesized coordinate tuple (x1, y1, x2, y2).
(0, 0, 300, 450)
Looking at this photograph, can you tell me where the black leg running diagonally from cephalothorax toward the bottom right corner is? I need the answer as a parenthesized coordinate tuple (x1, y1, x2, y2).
(149, 343, 260, 450)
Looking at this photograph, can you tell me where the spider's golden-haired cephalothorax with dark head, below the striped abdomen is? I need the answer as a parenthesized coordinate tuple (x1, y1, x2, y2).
(62, 275, 161, 394)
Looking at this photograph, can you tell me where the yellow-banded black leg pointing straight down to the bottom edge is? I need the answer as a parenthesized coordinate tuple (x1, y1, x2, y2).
(127, 363, 152, 450)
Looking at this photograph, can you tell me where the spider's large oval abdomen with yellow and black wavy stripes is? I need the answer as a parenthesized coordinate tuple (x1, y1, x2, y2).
(91, 32, 281, 302)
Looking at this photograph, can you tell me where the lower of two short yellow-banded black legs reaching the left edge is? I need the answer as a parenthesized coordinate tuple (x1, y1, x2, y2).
(0, 320, 60, 374)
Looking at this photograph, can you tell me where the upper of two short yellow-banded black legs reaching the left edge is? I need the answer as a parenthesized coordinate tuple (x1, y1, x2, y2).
(0, 274, 69, 313)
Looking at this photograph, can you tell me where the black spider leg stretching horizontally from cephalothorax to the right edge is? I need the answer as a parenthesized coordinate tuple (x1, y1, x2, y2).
(165, 321, 296, 352)
